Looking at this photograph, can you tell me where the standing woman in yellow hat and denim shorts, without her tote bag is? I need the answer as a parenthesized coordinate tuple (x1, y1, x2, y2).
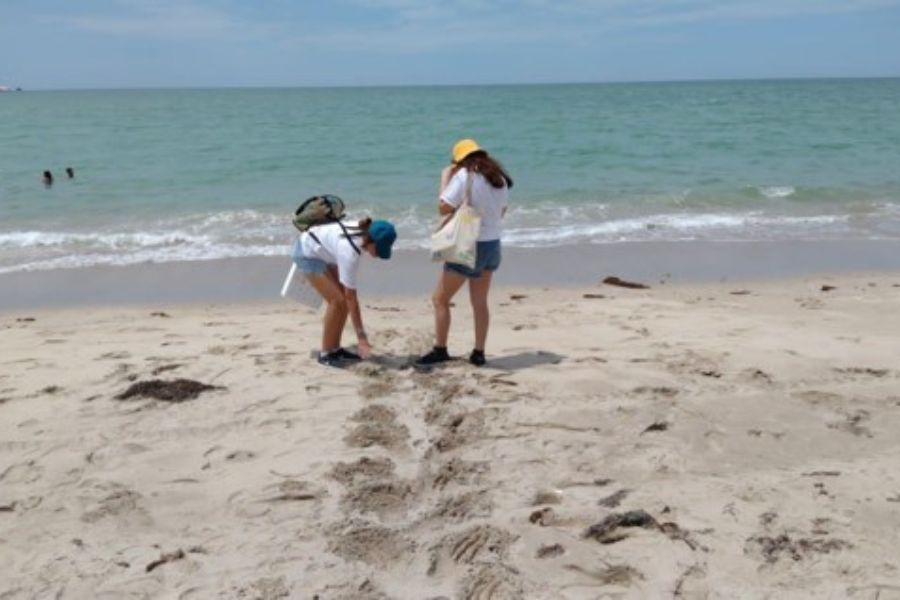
(416, 139, 513, 367)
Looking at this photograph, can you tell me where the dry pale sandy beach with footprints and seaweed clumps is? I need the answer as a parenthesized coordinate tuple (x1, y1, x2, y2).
(0, 273, 900, 600)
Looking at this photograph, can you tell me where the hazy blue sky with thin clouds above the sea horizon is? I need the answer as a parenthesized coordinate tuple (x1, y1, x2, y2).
(0, 0, 900, 89)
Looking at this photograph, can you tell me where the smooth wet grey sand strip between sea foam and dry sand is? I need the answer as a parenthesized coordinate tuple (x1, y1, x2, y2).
(0, 240, 900, 312)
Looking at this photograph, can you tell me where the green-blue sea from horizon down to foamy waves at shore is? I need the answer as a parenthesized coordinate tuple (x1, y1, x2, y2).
(0, 79, 900, 273)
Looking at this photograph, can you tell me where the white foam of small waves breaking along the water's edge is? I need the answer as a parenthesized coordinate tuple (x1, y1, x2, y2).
(0, 203, 900, 273)
